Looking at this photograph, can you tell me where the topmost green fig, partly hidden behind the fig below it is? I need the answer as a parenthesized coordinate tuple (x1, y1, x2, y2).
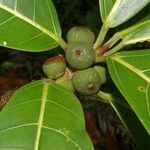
(67, 26, 95, 44)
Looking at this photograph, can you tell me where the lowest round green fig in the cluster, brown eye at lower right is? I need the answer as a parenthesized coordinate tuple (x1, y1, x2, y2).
(72, 68, 101, 95)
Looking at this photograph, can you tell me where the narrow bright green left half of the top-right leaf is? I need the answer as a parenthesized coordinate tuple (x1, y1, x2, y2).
(99, 0, 116, 23)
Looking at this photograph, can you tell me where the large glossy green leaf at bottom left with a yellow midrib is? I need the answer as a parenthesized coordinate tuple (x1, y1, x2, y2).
(0, 80, 93, 150)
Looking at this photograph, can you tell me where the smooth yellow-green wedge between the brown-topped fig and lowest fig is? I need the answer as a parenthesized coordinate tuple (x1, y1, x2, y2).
(56, 76, 74, 92)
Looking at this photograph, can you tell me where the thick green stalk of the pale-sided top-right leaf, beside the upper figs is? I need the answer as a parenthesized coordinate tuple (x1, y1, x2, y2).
(94, 24, 109, 49)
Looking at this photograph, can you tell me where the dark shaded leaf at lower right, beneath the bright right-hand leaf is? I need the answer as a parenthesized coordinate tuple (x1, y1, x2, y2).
(110, 93, 150, 150)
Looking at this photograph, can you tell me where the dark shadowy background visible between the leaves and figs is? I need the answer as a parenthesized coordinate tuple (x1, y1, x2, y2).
(0, 0, 150, 150)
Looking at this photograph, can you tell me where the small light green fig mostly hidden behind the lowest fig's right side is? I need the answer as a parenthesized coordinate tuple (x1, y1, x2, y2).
(94, 66, 107, 84)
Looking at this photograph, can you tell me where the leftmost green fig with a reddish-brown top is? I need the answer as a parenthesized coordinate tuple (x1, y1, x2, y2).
(43, 55, 66, 79)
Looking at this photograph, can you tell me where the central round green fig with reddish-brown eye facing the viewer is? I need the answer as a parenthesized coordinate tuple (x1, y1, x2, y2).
(66, 42, 95, 69)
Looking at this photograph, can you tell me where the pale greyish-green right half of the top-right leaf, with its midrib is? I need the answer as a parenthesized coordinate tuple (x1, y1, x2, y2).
(106, 0, 150, 28)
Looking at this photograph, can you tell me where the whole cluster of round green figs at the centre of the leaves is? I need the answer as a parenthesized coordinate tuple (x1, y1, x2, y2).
(43, 26, 106, 95)
